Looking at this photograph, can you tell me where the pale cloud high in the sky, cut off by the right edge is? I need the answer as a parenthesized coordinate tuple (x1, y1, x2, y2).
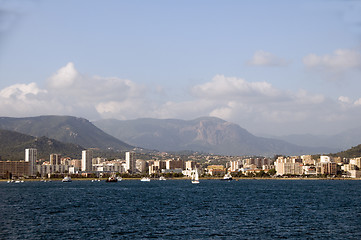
(303, 49, 361, 72)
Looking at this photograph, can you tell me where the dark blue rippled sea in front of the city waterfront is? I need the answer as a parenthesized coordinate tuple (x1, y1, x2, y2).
(0, 179, 361, 239)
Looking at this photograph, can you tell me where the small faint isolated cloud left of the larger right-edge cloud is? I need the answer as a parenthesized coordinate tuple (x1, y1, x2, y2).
(248, 50, 289, 67)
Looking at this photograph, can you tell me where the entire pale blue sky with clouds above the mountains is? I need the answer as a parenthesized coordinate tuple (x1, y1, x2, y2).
(0, 0, 361, 136)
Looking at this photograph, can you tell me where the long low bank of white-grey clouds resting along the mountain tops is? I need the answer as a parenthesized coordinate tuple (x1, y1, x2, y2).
(0, 62, 361, 134)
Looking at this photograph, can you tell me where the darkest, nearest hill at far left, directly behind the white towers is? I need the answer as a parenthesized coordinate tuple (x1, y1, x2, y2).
(0, 129, 84, 160)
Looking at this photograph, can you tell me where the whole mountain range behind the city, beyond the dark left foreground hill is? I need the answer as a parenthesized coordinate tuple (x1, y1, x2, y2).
(0, 116, 346, 156)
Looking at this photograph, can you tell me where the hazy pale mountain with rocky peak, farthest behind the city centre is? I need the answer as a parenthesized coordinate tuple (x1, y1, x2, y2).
(93, 117, 332, 155)
